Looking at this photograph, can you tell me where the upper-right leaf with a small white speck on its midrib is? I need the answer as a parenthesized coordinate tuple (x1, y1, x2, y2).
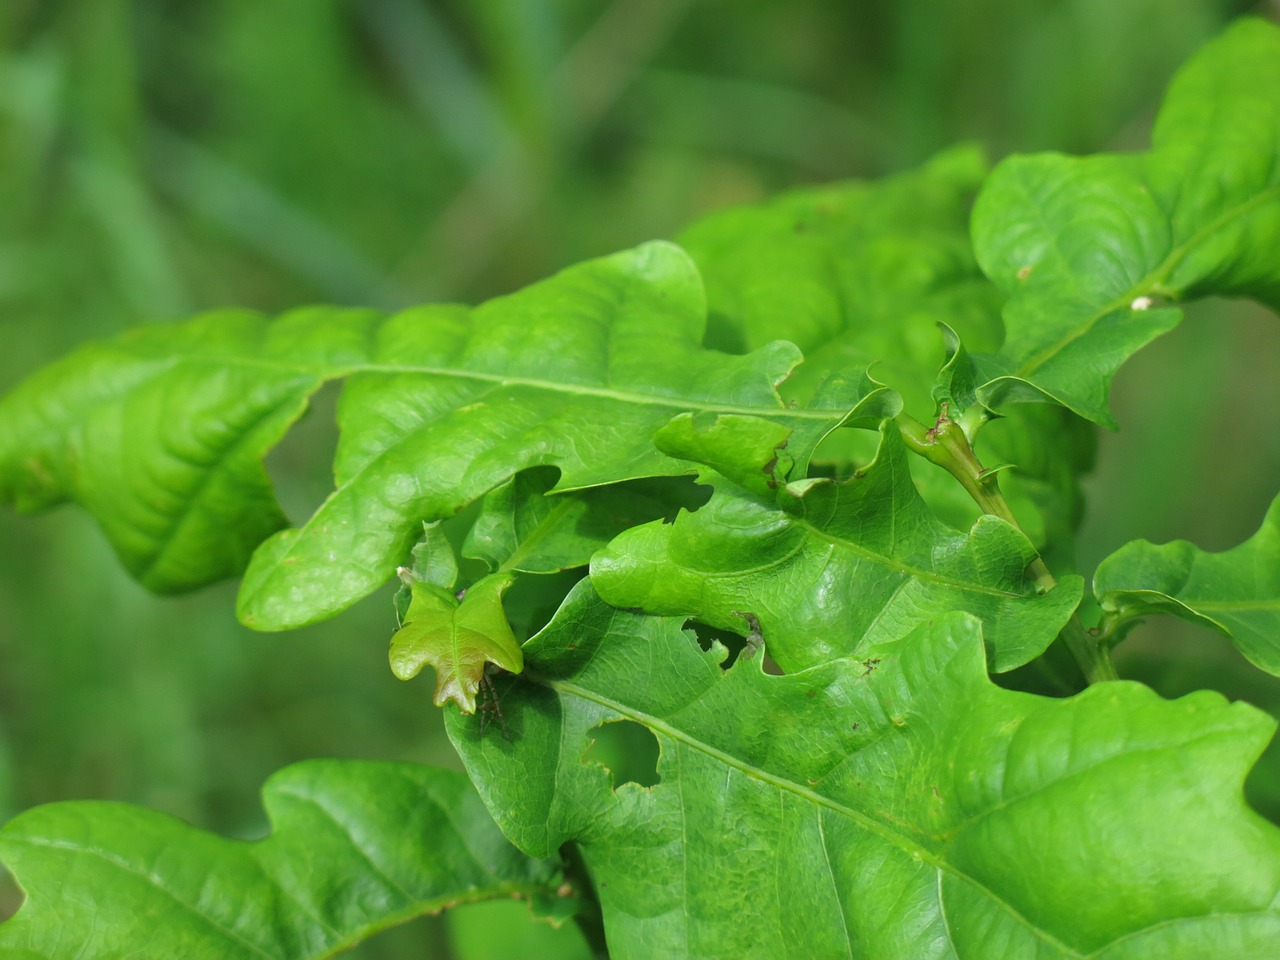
(973, 19, 1280, 426)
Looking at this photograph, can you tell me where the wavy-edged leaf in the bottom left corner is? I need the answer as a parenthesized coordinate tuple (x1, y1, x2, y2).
(0, 760, 570, 960)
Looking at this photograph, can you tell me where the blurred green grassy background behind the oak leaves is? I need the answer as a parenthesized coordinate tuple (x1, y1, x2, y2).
(0, 0, 1280, 960)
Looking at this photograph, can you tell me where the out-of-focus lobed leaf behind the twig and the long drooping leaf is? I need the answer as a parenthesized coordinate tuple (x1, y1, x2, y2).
(680, 147, 1093, 570)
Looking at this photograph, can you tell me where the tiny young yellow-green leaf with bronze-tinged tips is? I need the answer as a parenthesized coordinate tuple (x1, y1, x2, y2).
(390, 573, 525, 713)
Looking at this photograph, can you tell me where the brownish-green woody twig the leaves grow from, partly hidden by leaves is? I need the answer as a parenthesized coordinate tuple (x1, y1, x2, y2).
(895, 403, 1119, 684)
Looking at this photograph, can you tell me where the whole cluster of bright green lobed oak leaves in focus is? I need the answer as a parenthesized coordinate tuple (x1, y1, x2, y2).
(0, 13, 1280, 960)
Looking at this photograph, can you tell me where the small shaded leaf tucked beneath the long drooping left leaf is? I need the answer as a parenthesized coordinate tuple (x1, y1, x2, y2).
(462, 468, 698, 573)
